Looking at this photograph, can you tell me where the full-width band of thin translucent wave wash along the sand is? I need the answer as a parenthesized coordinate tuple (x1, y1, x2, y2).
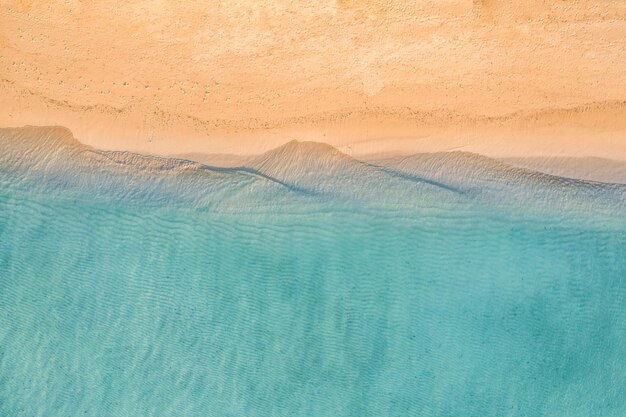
(0, 127, 626, 213)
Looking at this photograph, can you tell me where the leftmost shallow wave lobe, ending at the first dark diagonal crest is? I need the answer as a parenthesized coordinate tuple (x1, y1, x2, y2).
(0, 127, 302, 208)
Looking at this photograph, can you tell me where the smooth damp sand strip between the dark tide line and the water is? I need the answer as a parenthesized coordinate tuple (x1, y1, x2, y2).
(0, 97, 626, 162)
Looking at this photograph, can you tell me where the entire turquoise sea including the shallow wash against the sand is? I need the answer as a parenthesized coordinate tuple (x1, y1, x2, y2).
(0, 128, 626, 417)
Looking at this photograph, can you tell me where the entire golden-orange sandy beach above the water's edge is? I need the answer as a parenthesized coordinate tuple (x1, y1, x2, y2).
(0, 0, 626, 162)
